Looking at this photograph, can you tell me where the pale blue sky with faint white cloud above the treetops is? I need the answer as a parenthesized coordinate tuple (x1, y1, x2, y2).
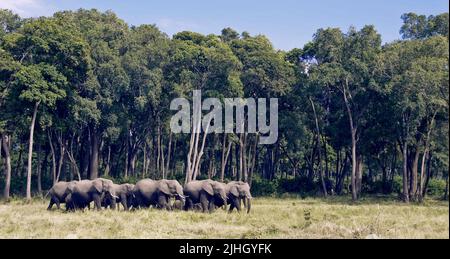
(0, 0, 449, 50)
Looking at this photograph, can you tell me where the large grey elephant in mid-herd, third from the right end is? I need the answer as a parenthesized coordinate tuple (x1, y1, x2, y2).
(133, 179, 185, 210)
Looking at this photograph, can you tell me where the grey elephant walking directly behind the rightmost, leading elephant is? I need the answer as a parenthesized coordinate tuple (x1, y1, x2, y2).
(183, 180, 227, 213)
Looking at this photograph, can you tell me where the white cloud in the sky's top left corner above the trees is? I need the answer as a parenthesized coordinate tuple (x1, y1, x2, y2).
(0, 0, 54, 17)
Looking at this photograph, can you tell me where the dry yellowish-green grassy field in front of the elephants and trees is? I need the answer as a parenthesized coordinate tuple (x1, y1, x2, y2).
(0, 198, 449, 239)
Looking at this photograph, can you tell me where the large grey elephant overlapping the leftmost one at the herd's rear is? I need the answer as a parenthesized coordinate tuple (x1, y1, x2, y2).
(71, 178, 119, 210)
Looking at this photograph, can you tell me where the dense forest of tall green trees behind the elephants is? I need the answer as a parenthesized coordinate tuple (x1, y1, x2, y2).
(0, 9, 449, 202)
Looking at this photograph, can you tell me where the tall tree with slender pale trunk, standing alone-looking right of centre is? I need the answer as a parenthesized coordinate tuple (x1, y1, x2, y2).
(305, 26, 381, 200)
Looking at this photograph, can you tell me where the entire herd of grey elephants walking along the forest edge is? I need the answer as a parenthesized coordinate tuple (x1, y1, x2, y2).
(47, 178, 252, 213)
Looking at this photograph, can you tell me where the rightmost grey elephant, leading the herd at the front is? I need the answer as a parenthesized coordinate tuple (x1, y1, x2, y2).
(227, 181, 253, 213)
